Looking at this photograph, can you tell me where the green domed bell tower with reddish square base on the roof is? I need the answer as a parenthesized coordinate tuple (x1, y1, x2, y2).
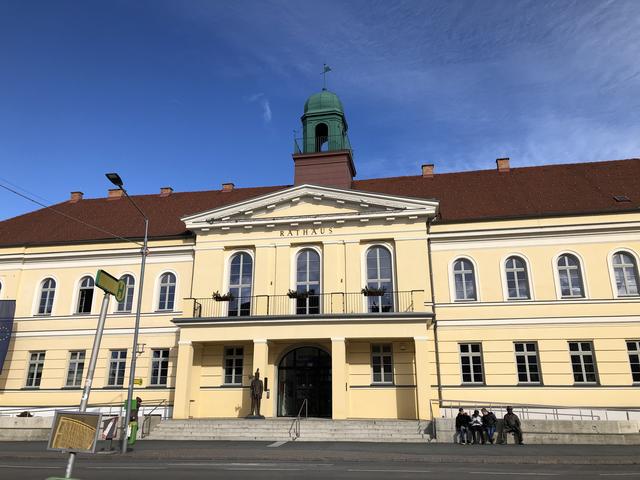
(293, 89, 356, 188)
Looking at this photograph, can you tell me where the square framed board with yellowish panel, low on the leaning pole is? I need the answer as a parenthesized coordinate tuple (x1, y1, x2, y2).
(47, 412, 102, 453)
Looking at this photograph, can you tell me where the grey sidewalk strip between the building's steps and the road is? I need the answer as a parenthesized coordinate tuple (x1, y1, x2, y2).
(0, 440, 640, 465)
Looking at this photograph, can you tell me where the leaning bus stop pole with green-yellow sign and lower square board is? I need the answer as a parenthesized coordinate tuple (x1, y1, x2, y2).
(52, 270, 125, 478)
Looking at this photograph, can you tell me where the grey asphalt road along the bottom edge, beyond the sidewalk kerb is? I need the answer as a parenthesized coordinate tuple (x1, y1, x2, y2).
(0, 458, 640, 480)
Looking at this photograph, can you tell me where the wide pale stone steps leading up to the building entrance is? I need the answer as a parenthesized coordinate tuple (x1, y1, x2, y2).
(145, 418, 427, 443)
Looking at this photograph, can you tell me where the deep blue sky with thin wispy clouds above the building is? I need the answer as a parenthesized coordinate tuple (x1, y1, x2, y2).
(0, 0, 640, 218)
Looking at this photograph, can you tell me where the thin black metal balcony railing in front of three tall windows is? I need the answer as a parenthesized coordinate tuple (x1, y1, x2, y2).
(188, 290, 424, 318)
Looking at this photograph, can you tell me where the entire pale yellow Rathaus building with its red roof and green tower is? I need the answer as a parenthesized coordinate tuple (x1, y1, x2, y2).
(0, 91, 640, 419)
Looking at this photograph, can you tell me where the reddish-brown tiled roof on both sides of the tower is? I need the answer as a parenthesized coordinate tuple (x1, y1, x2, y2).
(0, 158, 640, 246)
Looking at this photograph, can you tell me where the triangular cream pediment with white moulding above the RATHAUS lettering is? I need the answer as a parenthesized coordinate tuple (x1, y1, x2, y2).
(182, 185, 438, 230)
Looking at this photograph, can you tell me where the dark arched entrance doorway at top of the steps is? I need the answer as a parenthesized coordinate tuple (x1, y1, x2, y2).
(278, 347, 331, 418)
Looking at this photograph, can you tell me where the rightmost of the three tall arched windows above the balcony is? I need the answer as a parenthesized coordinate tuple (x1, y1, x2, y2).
(367, 246, 393, 313)
